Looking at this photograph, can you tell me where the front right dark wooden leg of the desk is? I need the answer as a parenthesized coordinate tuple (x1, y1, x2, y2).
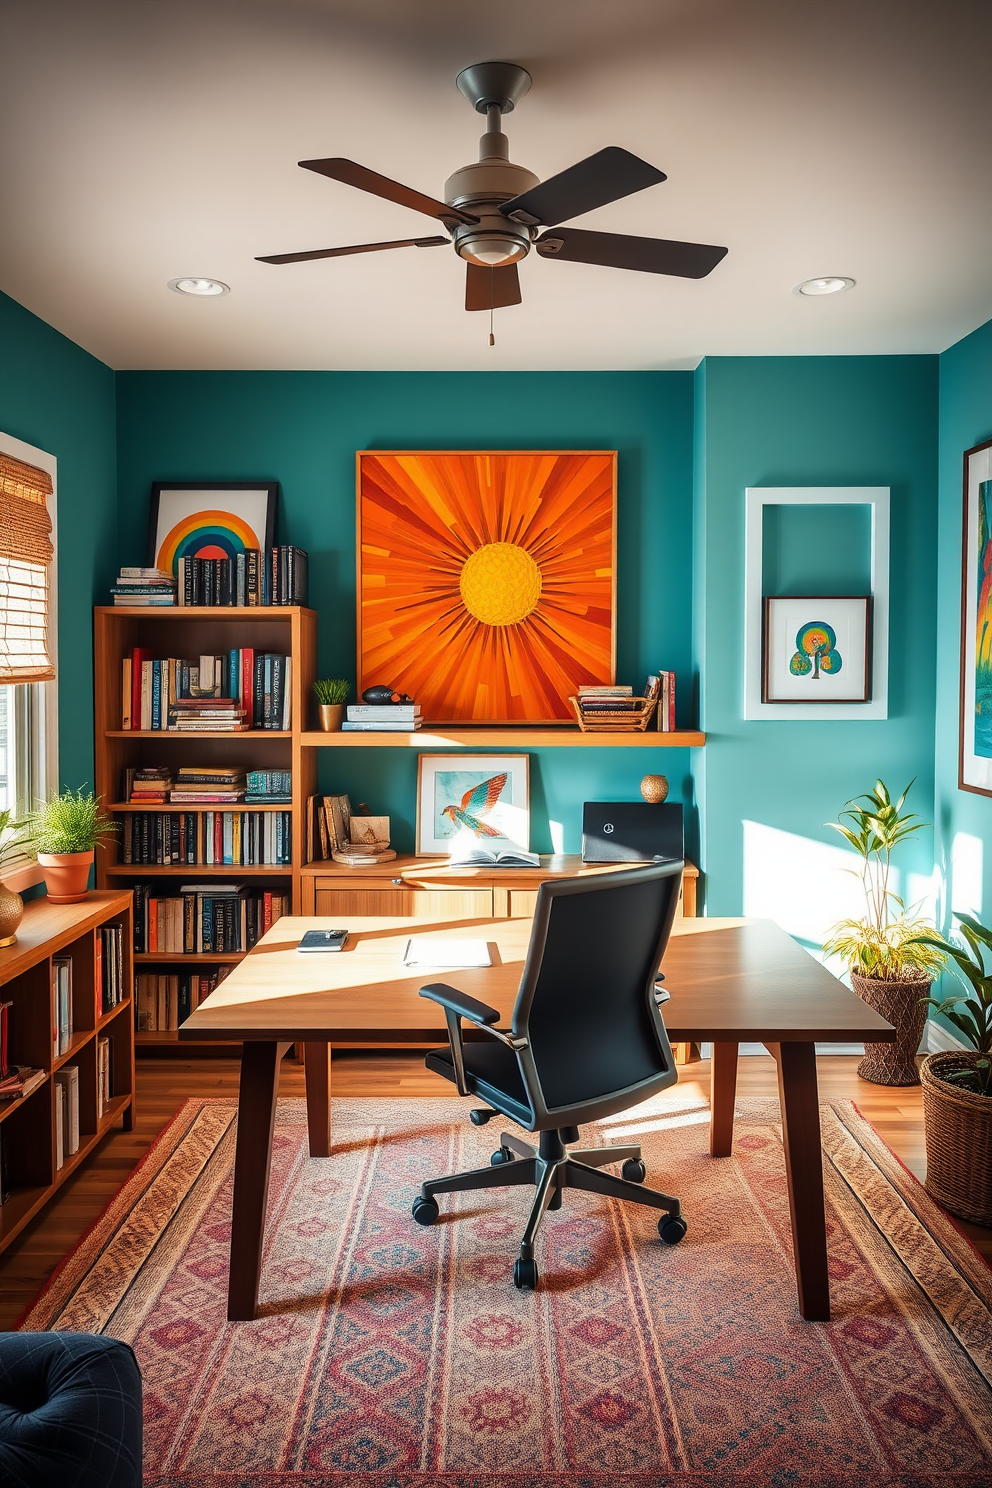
(773, 1043, 830, 1323)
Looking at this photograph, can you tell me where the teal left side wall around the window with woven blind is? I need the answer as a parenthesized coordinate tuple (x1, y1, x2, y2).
(0, 295, 117, 787)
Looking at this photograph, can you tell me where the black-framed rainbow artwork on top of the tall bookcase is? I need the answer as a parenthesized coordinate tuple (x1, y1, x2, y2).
(149, 481, 280, 574)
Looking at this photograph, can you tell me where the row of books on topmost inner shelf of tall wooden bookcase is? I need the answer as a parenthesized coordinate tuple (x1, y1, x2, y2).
(120, 646, 293, 734)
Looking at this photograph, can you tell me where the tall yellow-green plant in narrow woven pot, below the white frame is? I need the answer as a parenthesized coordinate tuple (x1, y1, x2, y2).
(824, 780, 947, 1085)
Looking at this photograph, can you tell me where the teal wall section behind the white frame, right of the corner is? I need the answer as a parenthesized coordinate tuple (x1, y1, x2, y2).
(693, 357, 937, 939)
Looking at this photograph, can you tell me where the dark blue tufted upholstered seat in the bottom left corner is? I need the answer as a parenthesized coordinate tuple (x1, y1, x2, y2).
(0, 1333, 141, 1488)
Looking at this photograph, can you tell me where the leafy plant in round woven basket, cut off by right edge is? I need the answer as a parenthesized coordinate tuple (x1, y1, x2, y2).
(921, 915, 992, 1225)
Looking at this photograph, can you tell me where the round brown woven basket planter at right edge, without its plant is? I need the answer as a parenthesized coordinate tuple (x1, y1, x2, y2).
(921, 1051, 992, 1225)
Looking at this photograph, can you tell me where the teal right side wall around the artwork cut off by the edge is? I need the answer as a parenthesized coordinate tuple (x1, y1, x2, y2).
(934, 321, 992, 934)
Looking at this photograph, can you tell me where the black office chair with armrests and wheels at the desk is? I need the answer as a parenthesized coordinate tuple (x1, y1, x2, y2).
(413, 863, 687, 1290)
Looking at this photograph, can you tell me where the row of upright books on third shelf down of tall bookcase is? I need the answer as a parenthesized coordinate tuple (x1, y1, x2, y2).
(120, 805, 293, 868)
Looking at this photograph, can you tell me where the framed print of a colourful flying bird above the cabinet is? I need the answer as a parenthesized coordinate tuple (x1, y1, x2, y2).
(416, 754, 531, 857)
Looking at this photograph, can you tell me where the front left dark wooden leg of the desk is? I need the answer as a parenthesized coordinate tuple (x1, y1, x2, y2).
(228, 1042, 286, 1323)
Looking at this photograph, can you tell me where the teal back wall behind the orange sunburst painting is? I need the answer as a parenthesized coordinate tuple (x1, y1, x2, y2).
(117, 372, 693, 851)
